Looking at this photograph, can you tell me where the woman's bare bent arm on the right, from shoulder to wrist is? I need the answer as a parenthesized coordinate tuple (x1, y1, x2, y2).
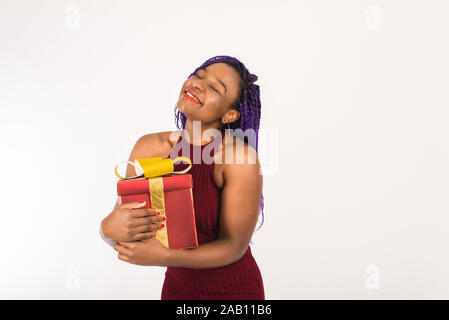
(166, 144, 263, 268)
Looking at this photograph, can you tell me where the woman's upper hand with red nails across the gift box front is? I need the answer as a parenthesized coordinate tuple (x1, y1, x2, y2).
(101, 202, 164, 241)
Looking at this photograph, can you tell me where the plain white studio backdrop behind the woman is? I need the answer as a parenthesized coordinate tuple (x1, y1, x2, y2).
(0, 0, 449, 299)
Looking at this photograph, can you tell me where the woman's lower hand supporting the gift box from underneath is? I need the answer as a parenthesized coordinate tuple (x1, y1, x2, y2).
(114, 238, 170, 267)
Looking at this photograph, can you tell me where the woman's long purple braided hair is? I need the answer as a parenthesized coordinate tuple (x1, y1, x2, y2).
(175, 56, 264, 230)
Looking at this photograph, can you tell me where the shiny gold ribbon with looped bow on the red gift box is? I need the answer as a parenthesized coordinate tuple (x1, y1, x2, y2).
(114, 157, 192, 248)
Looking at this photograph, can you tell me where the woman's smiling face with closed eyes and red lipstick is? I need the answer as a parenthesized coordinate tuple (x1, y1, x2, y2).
(177, 62, 241, 128)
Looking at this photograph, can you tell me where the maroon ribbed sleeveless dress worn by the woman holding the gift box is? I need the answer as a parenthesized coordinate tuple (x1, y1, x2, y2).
(161, 130, 265, 300)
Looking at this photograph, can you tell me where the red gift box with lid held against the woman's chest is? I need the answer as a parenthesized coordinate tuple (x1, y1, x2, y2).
(117, 174, 198, 249)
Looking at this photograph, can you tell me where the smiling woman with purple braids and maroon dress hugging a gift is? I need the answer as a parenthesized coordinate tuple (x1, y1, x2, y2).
(100, 56, 265, 299)
